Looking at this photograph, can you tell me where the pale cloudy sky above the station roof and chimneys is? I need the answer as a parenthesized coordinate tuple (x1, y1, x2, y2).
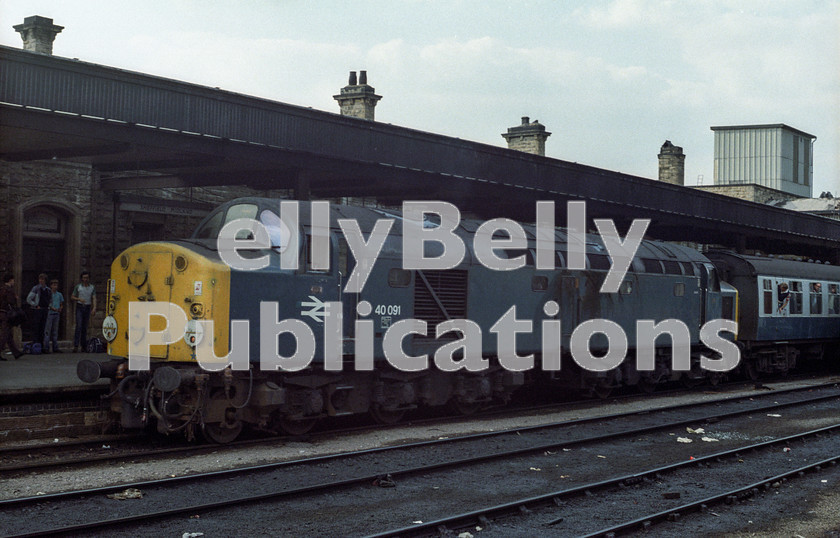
(0, 0, 840, 196)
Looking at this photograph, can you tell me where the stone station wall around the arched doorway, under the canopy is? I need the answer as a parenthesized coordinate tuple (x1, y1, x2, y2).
(0, 157, 290, 338)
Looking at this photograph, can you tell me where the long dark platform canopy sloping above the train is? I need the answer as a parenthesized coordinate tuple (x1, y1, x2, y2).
(0, 47, 840, 263)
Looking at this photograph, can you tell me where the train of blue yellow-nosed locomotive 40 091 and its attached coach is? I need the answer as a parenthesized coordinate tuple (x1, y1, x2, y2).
(78, 198, 840, 442)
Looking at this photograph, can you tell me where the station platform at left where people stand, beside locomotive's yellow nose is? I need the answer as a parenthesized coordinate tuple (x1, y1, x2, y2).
(0, 351, 112, 401)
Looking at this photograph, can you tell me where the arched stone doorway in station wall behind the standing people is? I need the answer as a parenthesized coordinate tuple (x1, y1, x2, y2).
(18, 201, 79, 341)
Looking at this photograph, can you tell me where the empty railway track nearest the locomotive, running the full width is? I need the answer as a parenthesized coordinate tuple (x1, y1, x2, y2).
(0, 378, 840, 536)
